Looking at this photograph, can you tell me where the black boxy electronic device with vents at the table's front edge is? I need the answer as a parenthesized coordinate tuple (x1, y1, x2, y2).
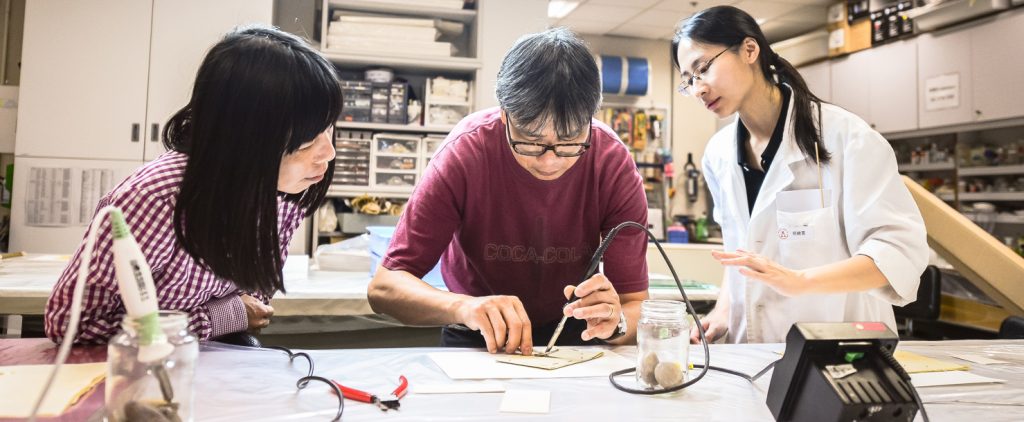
(767, 323, 927, 422)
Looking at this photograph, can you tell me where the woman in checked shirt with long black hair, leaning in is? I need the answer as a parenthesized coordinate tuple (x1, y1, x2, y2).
(45, 27, 341, 343)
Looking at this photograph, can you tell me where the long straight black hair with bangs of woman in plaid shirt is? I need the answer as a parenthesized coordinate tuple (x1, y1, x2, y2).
(163, 27, 342, 295)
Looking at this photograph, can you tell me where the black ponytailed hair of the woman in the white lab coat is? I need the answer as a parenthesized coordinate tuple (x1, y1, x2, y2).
(672, 6, 831, 164)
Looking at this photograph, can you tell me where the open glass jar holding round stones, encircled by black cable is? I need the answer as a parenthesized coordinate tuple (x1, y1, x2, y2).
(637, 300, 690, 388)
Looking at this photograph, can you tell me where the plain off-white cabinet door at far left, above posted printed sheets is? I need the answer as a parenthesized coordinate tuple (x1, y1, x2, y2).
(14, 0, 153, 160)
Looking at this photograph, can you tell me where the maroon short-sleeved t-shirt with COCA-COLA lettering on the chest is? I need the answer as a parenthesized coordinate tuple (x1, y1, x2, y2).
(383, 108, 647, 325)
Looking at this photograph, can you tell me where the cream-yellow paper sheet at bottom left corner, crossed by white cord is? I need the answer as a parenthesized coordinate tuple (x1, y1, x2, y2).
(0, 362, 106, 418)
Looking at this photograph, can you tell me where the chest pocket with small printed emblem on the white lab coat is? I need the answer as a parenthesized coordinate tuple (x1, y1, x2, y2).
(775, 207, 840, 269)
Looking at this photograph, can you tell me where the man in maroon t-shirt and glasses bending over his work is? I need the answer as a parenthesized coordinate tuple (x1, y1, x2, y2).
(368, 29, 647, 354)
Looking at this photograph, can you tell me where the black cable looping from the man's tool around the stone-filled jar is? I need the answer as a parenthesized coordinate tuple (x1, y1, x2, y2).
(584, 221, 777, 395)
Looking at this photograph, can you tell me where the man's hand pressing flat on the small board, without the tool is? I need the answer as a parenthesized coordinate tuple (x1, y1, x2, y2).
(456, 296, 534, 355)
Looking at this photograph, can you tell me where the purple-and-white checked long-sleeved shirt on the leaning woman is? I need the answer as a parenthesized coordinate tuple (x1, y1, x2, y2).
(45, 152, 303, 343)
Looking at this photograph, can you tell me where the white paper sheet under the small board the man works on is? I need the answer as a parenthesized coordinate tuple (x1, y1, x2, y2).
(429, 350, 634, 380)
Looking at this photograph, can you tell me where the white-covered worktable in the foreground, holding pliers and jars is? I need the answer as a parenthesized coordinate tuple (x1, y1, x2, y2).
(0, 339, 1024, 422)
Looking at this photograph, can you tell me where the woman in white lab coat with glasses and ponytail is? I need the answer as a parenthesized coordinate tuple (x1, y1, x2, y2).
(672, 6, 928, 342)
